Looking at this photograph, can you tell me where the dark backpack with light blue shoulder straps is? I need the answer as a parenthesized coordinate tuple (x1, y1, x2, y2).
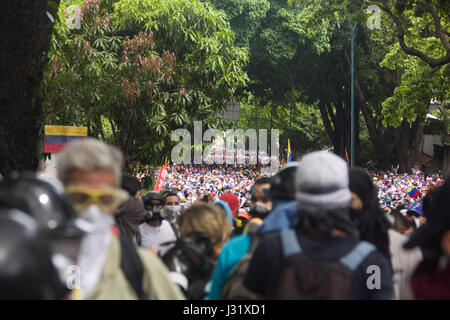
(276, 229, 375, 300)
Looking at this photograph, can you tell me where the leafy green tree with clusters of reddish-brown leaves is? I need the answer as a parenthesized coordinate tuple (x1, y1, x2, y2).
(44, 0, 248, 169)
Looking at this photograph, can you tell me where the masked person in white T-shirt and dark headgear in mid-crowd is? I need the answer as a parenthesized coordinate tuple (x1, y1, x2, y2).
(138, 192, 177, 256)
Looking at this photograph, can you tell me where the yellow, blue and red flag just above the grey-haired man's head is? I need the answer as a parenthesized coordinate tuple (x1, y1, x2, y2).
(44, 126, 87, 153)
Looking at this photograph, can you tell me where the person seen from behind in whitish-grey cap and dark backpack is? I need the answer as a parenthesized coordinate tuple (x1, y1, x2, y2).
(244, 152, 393, 300)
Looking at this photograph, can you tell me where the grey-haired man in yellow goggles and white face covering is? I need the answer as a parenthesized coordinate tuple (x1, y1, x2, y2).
(58, 138, 184, 300)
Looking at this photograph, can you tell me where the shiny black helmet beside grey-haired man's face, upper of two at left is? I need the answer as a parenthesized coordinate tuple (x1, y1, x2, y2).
(0, 173, 82, 237)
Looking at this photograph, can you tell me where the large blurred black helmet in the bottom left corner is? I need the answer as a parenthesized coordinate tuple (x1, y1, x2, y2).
(0, 208, 69, 300)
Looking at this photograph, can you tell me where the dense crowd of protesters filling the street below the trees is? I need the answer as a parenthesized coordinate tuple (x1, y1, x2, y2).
(0, 138, 450, 300)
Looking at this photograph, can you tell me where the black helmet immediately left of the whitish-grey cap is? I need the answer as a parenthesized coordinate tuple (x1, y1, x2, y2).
(269, 165, 297, 200)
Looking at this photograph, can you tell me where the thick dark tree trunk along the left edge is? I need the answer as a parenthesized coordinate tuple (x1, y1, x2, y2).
(0, 0, 59, 174)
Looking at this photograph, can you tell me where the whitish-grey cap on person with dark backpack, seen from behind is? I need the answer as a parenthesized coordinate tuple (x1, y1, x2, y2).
(295, 151, 351, 210)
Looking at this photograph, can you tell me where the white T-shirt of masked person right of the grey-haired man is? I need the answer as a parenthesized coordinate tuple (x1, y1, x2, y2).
(139, 220, 177, 255)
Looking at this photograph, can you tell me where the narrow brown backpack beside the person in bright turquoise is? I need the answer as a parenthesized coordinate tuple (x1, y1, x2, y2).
(220, 233, 260, 300)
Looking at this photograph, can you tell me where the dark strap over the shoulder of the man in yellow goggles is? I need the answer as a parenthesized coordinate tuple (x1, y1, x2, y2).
(119, 235, 144, 300)
